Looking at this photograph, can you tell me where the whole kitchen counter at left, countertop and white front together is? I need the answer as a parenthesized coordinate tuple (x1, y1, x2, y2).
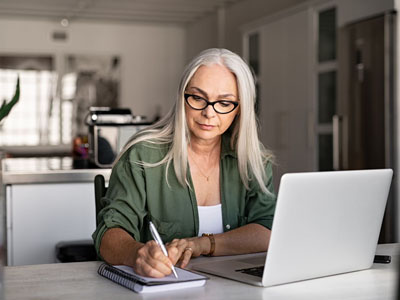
(0, 157, 111, 266)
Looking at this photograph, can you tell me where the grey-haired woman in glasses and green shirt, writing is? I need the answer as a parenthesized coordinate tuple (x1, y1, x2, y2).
(93, 49, 276, 277)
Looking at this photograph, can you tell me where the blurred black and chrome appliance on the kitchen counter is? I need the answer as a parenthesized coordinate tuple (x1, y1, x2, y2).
(86, 107, 151, 168)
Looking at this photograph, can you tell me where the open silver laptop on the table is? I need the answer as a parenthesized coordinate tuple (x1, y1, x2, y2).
(193, 169, 393, 287)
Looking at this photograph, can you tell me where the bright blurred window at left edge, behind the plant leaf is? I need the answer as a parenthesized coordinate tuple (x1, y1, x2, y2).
(0, 56, 72, 146)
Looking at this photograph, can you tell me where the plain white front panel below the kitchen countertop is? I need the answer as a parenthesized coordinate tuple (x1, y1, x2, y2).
(7, 183, 96, 265)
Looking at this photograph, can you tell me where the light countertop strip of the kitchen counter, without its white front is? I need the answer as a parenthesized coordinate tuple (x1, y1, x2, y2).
(2, 157, 111, 184)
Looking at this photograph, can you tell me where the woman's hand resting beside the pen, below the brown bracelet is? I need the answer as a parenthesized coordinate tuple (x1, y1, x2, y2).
(166, 237, 207, 268)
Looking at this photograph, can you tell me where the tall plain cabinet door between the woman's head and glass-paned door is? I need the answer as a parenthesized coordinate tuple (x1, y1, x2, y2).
(259, 10, 314, 185)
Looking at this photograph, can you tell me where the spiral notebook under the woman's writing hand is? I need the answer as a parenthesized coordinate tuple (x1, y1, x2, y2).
(97, 263, 208, 293)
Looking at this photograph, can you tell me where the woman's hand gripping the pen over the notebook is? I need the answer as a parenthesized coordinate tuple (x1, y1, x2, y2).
(133, 241, 177, 278)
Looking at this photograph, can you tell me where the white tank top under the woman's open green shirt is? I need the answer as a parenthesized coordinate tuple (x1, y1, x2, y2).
(198, 204, 224, 236)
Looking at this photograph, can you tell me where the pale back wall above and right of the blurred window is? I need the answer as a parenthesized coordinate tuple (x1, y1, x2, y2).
(0, 18, 185, 118)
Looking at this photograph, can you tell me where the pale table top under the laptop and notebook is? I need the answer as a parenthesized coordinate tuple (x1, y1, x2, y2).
(4, 244, 400, 300)
